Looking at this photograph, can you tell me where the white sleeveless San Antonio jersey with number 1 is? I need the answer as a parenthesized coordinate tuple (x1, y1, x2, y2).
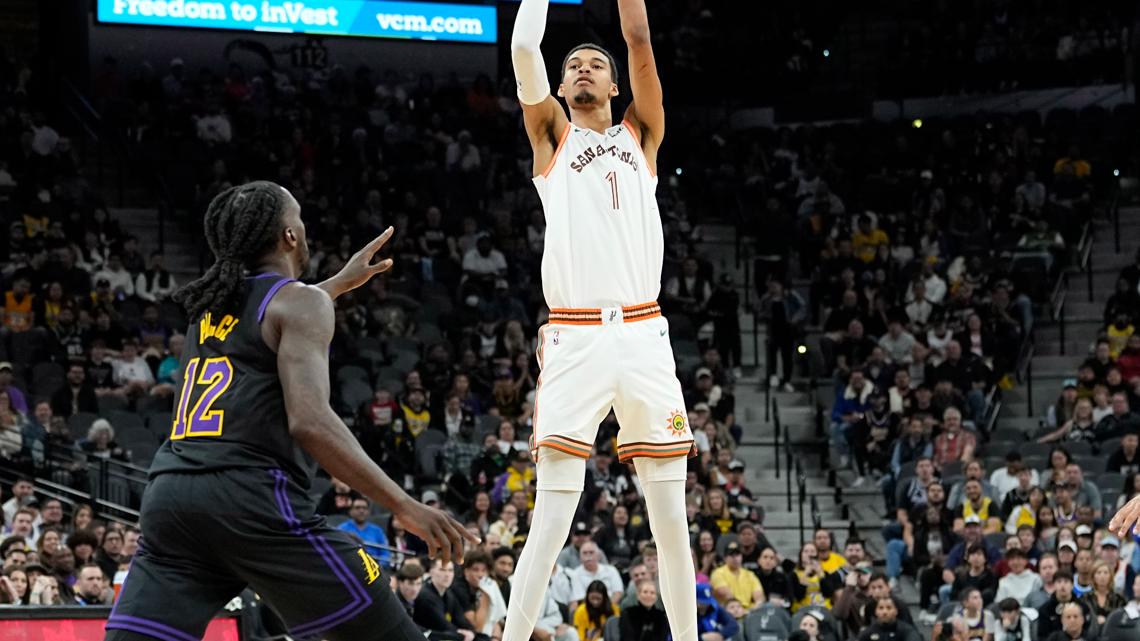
(535, 121, 665, 309)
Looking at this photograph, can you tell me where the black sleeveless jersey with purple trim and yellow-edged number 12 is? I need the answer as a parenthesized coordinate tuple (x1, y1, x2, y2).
(150, 274, 316, 488)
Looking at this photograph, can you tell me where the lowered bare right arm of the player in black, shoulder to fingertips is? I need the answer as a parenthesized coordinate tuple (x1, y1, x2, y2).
(267, 285, 478, 561)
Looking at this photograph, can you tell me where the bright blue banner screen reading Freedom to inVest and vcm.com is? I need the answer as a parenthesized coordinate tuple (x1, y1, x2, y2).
(96, 0, 498, 42)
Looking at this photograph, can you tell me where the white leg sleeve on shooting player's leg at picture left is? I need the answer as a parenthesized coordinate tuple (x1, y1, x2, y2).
(503, 449, 586, 641)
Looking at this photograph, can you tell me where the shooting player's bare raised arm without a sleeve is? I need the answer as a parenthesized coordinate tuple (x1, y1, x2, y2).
(618, 0, 665, 164)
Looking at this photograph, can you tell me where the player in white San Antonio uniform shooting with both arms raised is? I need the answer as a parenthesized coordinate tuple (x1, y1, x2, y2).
(503, 0, 697, 641)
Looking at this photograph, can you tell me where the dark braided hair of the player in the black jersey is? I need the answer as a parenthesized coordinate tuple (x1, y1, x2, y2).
(174, 180, 285, 322)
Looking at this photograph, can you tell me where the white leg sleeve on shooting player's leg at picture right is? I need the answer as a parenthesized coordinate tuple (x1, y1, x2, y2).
(638, 459, 697, 641)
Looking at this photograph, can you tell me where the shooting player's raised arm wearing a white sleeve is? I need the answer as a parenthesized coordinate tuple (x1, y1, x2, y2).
(511, 0, 569, 176)
